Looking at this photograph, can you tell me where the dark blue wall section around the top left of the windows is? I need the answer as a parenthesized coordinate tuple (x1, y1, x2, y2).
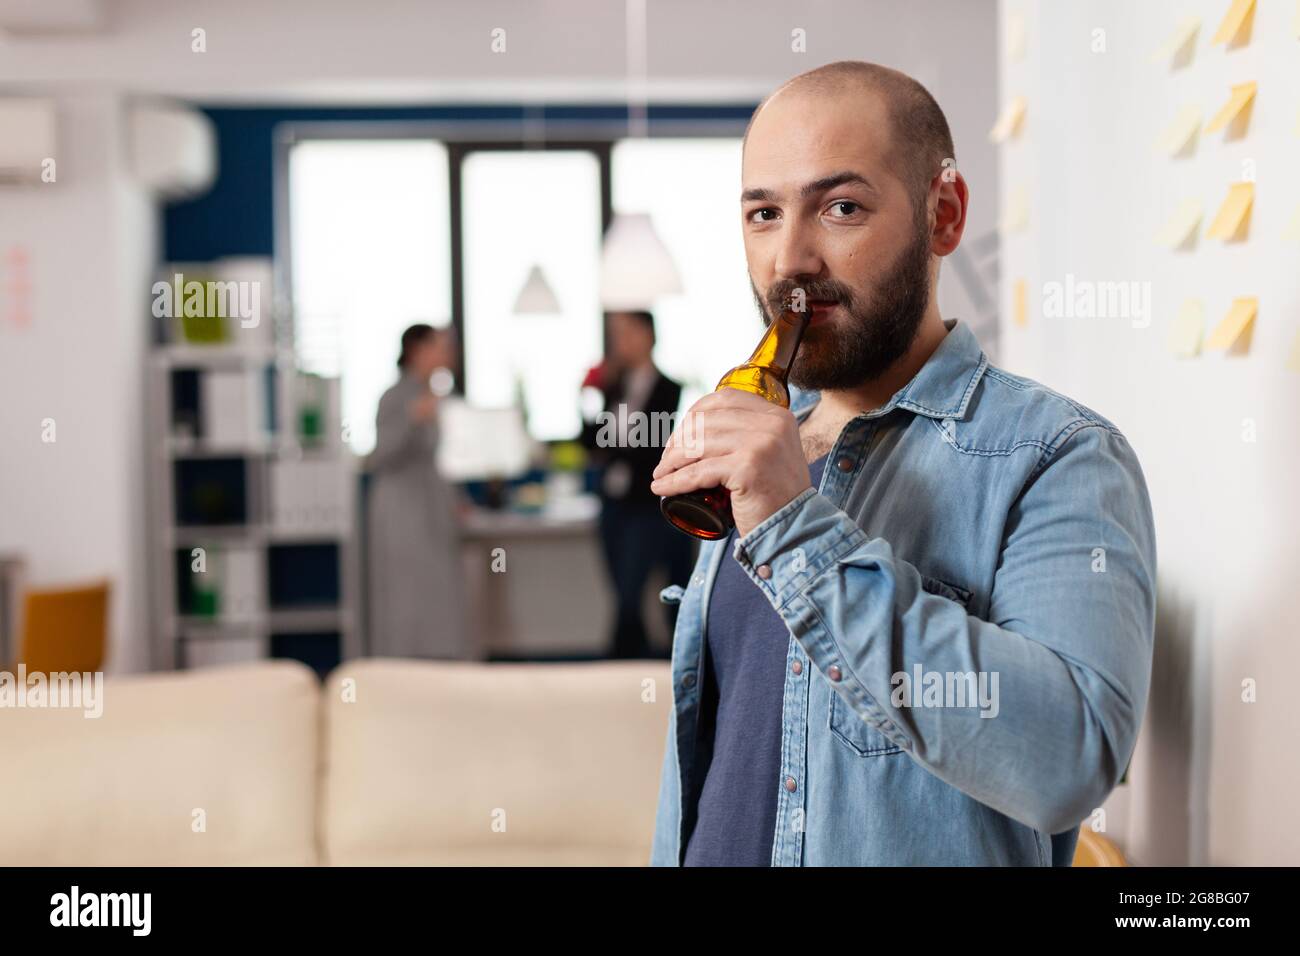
(164, 104, 757, 261)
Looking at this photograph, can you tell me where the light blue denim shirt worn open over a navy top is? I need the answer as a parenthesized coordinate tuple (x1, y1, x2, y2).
(650, 320, 1156, 866)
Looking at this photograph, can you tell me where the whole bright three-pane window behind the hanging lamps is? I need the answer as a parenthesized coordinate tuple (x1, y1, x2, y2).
(287, 134, 762, 454)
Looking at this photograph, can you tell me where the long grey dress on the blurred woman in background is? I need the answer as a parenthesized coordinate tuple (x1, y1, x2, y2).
(367, 376, 478, 659)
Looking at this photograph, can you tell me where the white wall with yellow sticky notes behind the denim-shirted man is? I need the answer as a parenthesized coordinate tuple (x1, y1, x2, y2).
(1000, 0, 1300, 865)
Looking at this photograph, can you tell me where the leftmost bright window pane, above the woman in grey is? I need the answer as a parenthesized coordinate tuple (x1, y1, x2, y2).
(289, 139, 451, 454)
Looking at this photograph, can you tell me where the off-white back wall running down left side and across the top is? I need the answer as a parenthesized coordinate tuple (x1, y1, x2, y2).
(0, 0, 997, 670)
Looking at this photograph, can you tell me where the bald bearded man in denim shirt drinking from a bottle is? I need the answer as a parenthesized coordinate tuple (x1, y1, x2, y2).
(651, 61, 1156, 866)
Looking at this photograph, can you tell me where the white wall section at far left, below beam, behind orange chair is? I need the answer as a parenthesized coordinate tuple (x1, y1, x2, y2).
(0, 95, 156, 670)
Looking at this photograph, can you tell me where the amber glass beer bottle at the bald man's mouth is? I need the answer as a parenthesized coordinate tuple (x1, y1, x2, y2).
(659, 307, 809, 541)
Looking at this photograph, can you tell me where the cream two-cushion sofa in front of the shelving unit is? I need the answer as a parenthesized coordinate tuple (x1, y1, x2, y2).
(0, 659, 672, 866)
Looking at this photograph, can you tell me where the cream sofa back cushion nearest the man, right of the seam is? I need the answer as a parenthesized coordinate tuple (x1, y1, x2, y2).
(321, 659, 672, 866)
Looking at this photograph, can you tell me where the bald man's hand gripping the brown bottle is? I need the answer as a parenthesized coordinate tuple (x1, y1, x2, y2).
(650, 389, 813, 537)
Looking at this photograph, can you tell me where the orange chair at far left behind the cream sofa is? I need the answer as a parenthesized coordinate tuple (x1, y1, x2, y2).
(10, 580, 109, 674)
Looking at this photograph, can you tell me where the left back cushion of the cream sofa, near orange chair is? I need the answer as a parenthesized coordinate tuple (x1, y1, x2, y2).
(0, 661, 320, 866)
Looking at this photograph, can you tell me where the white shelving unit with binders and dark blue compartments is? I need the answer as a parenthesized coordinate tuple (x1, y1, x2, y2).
(146, 263, 360, 667)
